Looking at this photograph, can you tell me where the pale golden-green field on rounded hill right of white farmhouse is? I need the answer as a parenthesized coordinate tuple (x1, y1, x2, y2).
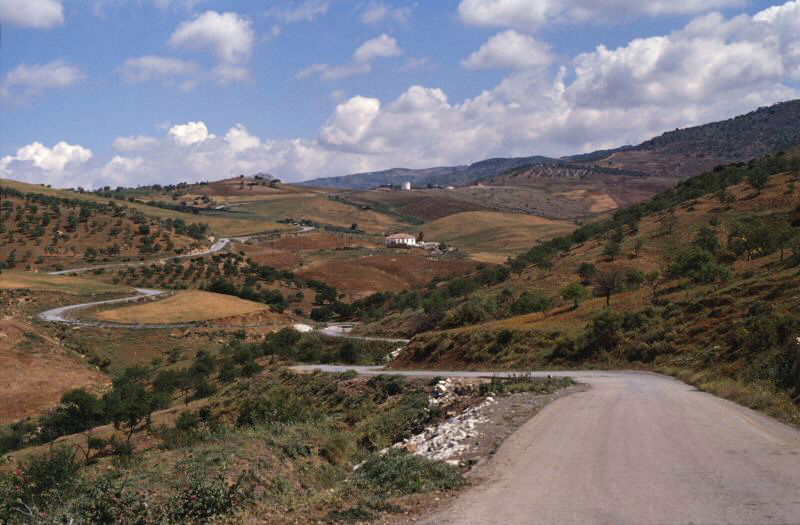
(421, 211, 575, 262)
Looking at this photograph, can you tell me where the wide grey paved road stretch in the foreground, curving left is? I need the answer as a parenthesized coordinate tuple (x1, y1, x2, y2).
(296, 367, 800, 525)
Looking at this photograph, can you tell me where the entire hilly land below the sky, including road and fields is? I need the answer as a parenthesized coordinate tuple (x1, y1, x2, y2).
(0, 103, 800, 523)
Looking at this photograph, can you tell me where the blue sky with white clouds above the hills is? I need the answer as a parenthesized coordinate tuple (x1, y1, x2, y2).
(0, 0, 800, 186)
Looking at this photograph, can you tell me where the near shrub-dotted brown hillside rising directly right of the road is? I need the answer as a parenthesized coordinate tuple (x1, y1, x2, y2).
(340, 149, 800, 423)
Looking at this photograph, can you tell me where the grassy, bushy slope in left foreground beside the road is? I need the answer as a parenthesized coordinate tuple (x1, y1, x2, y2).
(0, 357, 464, 523)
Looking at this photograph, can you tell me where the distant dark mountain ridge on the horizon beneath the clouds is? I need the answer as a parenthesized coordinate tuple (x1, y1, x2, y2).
(301, 100, 800, 190)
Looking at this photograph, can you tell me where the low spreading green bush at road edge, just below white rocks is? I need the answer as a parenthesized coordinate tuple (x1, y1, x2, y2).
(356, 449, 465, 496)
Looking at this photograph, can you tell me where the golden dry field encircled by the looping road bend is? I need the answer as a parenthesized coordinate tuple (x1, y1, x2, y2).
(95, 290, 267, 324)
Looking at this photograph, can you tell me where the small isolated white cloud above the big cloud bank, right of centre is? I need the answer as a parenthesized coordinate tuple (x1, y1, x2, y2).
(461, 29, 553, 69)
